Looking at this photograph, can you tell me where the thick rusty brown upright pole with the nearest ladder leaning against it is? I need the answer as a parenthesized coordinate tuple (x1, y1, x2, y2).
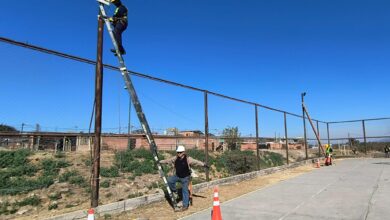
(91, 16, 104, 208)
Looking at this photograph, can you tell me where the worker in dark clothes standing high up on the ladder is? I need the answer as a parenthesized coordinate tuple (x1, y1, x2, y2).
(109, 0, 127, 55)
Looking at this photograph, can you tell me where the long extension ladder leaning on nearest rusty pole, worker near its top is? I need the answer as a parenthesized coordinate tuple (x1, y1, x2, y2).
(97, 0, 178, 210)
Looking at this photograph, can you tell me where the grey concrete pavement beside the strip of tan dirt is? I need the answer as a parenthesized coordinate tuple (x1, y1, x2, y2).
(184, 158, 390, 220)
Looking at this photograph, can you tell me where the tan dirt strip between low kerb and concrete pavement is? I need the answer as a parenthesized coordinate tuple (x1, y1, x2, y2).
(102, 165, 315, 220)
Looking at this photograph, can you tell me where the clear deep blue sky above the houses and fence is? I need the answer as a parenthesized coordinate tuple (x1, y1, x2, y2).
(0, 0, 390, 136)
